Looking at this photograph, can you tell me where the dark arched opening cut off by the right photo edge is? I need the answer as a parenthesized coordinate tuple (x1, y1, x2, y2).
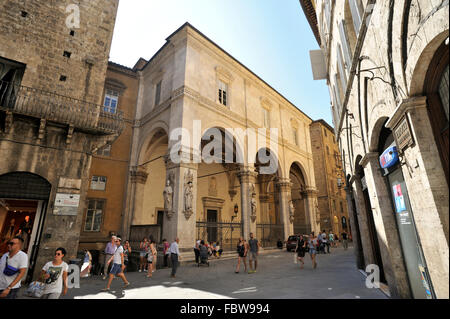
(424, 38, 449, 185)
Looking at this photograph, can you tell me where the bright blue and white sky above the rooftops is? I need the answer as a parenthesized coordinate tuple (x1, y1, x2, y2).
(110, 0, 332, 125)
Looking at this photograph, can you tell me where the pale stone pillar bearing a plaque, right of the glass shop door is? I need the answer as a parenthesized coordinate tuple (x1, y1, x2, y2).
(386, 96, 449, 298)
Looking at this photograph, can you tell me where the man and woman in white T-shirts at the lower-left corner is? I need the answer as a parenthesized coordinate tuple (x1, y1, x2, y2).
(0, 236, 69, 299)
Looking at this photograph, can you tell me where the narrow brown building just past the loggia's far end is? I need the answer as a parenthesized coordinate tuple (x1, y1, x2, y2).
(309, 120, 351, 236)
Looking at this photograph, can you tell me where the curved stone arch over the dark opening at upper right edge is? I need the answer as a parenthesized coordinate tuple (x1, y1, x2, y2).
(406, 12, 449, 97)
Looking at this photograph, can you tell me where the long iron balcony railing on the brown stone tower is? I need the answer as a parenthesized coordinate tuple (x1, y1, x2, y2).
(0, 81, 124, 134)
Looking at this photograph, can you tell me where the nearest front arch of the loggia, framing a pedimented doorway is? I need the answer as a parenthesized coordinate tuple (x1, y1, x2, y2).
(196, 127, 243, 251)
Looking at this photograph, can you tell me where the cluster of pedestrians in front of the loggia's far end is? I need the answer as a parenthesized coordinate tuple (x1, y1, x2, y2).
(295, 230, 348, 269)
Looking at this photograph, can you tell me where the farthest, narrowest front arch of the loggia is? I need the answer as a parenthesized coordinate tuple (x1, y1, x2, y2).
(289, 163, 312, 234)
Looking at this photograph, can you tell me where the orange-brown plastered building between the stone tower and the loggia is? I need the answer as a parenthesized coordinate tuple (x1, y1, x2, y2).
(79, 62, 139, 255)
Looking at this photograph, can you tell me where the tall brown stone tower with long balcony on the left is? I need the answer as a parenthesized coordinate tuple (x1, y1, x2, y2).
(0, 0, 122, 277)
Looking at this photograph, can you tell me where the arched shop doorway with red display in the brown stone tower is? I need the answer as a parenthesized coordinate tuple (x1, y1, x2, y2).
(0, 172, 52, 281)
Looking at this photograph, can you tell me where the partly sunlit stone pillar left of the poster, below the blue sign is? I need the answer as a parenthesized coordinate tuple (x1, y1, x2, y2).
(360, 152, 411, 298)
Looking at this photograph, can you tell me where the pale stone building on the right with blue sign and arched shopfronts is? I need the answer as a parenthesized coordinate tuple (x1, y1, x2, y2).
(300, 0, 449, 298)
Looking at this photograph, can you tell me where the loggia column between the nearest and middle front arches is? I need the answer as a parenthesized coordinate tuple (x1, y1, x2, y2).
(238, 168, 261, 240)
